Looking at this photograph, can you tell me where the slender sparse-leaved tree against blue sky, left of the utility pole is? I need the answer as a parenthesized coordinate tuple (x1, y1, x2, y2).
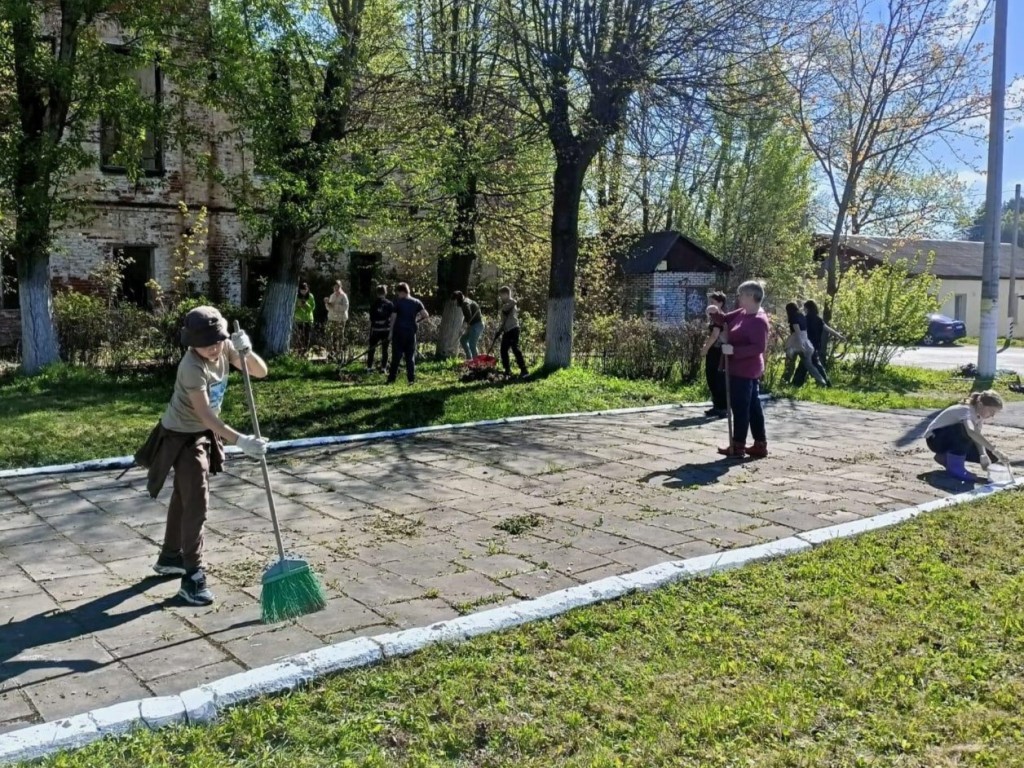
(779, 0, 988, 318)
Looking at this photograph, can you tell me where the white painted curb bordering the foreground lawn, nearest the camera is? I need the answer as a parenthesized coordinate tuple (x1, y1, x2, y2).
(0, 478, 1024, 765)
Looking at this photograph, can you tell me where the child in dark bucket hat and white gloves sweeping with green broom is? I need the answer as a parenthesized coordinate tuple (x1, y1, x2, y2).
(135, 306, 268, 605)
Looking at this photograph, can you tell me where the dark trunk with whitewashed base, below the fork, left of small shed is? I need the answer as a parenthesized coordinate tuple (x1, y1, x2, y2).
(544, 160, 585, 371)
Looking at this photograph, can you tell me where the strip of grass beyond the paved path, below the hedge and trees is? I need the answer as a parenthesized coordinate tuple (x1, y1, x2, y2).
(0, 359, 1020, 469)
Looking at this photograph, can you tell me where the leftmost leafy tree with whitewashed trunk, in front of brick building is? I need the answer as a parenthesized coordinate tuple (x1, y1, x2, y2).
(0, 0, 184, 373)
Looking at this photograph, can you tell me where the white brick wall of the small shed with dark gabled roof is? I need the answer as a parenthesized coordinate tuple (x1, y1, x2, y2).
(623, 272, 718, 325)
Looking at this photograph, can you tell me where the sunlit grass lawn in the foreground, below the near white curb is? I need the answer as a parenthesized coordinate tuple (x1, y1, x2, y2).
(32, 492, 1024, 768)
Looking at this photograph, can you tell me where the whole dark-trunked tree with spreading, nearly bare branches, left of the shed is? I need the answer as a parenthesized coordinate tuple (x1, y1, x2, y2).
(501, 0, 806, 370)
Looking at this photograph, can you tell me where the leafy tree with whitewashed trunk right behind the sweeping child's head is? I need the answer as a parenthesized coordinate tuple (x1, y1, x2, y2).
(207, 0, 406, 355)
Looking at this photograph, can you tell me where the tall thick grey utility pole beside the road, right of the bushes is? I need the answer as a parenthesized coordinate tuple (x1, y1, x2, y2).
(978, 0, 1008, 379)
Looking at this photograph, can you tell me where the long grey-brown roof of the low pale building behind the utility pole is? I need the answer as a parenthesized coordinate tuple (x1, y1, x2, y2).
(815, 234, 1024, 280)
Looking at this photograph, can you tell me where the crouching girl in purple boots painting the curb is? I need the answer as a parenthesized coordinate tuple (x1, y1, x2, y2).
(925, 389, 1009, 481)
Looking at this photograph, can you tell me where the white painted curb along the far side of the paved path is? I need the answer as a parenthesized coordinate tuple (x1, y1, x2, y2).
(0, 394, 771, 480)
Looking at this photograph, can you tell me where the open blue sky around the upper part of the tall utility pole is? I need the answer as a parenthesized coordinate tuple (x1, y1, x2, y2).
(930, 0, 1024, 217)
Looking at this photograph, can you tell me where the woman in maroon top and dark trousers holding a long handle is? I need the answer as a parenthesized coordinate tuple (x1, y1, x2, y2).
(711, 281, 769, 459)
